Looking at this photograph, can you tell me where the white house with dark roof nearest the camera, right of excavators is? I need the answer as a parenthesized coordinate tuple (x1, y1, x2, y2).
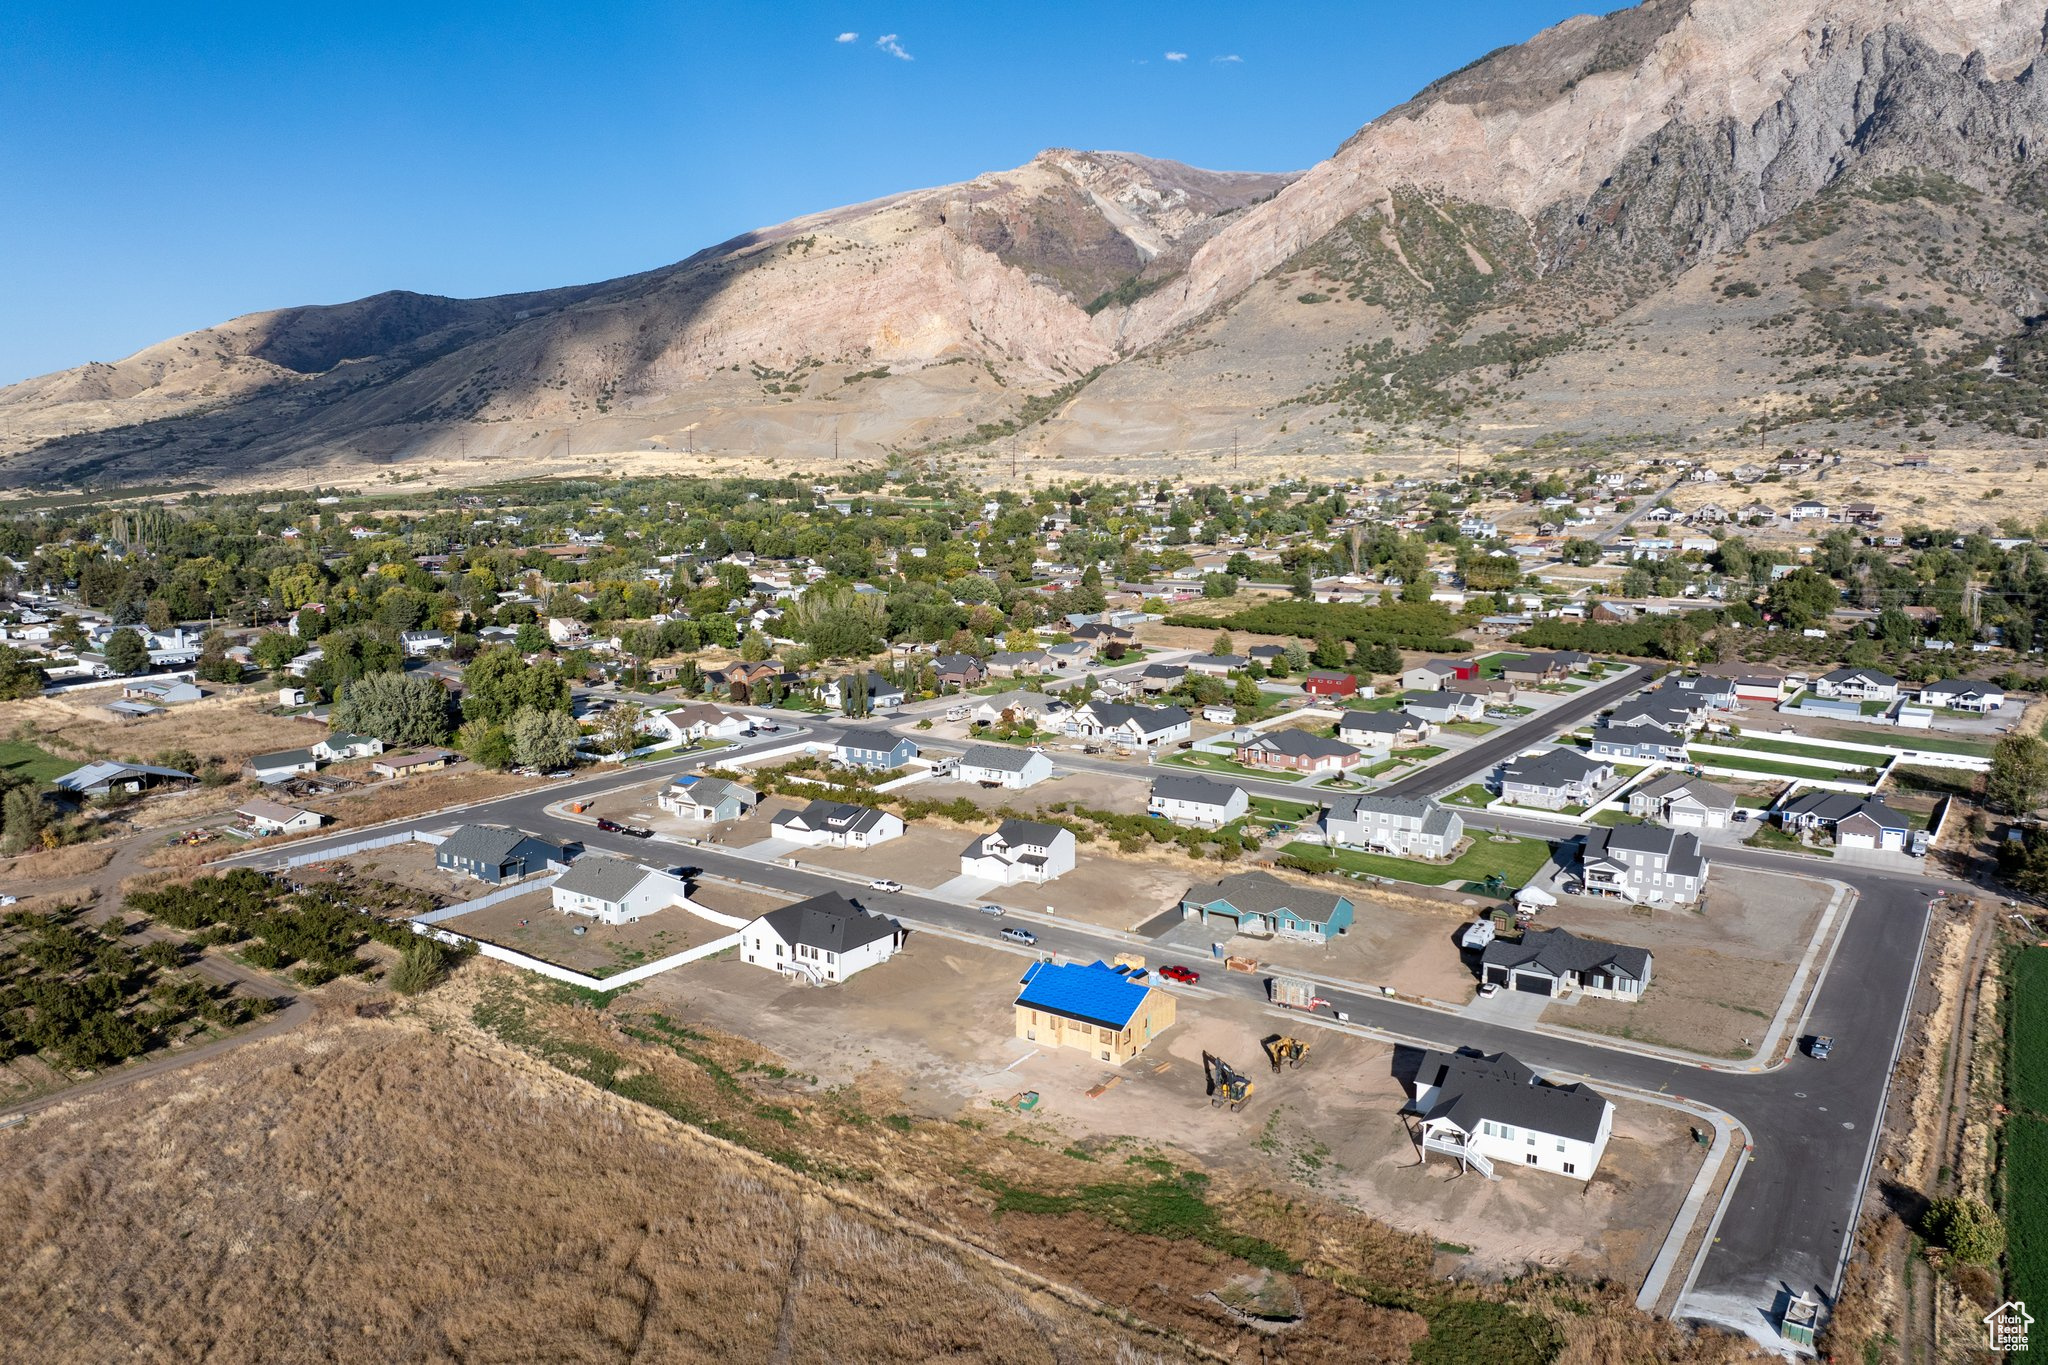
(1411, 1050, 1614, 1181)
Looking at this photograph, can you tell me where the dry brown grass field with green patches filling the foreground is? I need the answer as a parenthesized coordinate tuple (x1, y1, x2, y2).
(0, 962, 1743, 1365)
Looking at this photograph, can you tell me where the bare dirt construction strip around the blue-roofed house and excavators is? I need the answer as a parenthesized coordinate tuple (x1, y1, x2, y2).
(633, 935, 1698, 1281)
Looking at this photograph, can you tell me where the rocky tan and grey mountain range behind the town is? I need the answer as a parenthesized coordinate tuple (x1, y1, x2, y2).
(12, 0, 2048, 481)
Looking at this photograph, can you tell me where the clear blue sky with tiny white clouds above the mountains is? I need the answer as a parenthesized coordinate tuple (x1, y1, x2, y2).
(0, 0, 1618, 383)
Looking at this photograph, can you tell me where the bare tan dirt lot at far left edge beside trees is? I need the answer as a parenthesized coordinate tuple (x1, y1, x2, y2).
(0, 684, 328, 765)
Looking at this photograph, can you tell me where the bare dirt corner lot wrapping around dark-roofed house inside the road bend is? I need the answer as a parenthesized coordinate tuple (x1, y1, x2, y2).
(1538, 868, 1833, 1056)
